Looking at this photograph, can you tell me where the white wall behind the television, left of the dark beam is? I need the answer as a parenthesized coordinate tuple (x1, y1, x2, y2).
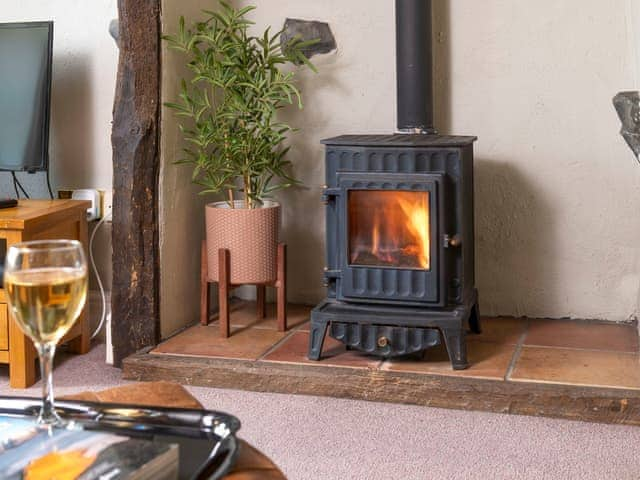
(0, 0, 118, 289)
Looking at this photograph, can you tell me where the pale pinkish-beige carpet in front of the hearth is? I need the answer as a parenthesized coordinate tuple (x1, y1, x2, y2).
(0, 346, 640, 480)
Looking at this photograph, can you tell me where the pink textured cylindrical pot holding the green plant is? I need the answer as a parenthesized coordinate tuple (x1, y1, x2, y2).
(205, 201, 281, 284)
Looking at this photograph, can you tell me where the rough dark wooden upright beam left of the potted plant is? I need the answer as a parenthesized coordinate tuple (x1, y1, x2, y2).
(111, 0, 161, 365)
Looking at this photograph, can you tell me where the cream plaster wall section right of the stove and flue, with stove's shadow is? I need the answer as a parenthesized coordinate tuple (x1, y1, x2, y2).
(444, 0, 640, 320)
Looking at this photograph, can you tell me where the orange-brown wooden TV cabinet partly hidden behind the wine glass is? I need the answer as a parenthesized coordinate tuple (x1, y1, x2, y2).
(0, 200, 91, 388)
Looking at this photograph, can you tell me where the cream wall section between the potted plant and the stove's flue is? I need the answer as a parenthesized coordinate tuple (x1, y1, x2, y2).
(234, 0, 395, 304)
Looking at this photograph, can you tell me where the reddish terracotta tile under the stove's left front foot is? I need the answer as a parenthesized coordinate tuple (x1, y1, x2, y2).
(262, 331, 380, 368)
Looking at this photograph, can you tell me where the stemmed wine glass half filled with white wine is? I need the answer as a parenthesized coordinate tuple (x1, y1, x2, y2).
(4, 240, 87, 426)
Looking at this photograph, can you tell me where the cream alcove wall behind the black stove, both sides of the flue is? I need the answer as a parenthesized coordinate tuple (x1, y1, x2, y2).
(163, 0, 640, 331)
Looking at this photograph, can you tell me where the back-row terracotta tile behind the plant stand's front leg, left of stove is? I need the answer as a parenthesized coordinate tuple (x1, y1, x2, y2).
(211, 300, 313, 330)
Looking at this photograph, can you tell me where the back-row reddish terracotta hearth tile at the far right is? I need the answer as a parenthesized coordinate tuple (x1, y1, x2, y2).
(524, 319, 638, 352)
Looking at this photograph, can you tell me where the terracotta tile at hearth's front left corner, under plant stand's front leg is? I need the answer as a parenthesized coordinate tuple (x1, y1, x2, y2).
(151, 325, 288, 360)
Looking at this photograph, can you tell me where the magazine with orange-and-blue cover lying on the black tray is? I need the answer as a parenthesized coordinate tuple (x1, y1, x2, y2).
(0, 415, 178, 480)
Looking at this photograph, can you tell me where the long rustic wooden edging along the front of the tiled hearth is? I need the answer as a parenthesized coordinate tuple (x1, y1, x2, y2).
(123, 350, 640, 425)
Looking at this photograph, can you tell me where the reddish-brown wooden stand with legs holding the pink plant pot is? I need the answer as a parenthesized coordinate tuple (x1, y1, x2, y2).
(200, 241, 287, 338)
